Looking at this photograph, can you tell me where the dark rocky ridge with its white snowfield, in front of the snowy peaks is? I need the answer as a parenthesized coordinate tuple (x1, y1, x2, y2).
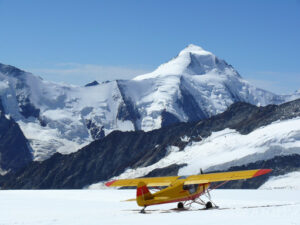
(0, 99, 300, 189)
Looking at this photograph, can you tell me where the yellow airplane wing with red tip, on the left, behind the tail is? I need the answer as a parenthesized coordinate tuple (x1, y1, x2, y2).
(105, 176, 179, 187)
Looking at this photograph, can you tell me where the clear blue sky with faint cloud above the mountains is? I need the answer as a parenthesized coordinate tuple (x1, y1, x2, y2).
(0, 0, 300, 93)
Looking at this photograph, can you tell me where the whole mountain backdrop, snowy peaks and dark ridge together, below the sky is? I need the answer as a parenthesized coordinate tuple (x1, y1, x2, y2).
(0, 45, 300, 189)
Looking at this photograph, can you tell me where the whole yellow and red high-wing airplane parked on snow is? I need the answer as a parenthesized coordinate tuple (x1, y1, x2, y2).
(105, 169, 272, 213)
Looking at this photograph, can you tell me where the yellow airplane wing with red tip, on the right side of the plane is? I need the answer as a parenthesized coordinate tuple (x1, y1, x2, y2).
(184, 169, 272, 185)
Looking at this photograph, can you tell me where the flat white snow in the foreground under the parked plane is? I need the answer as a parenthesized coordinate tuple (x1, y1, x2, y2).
(0, 190, 300, 225)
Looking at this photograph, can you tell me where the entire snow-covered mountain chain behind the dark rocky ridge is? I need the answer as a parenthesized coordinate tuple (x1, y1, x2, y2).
(0, 45, 300, 160)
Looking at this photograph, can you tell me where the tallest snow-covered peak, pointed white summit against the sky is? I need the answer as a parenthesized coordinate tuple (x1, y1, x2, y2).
(119, 45, 288, 131)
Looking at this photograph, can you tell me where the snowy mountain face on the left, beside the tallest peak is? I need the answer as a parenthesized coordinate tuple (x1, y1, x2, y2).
(0, 65, 134, 160)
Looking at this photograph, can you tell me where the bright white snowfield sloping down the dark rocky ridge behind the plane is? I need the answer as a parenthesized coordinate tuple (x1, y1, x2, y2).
(89, 118, 300, 189)
